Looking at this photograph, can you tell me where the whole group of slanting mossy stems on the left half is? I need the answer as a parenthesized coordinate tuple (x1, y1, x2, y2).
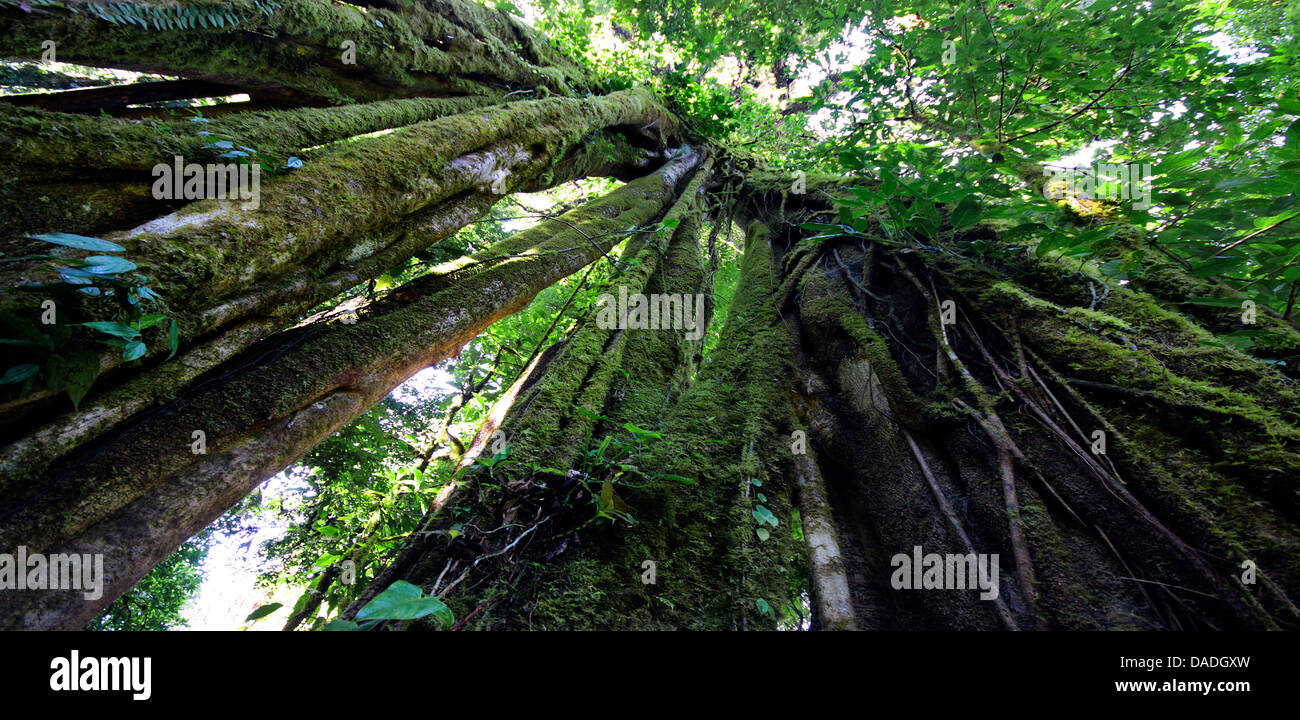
(0, 1, 699, 626)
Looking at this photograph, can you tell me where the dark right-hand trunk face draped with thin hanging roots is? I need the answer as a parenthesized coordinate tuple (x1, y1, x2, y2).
(781, 231, 1300, 629)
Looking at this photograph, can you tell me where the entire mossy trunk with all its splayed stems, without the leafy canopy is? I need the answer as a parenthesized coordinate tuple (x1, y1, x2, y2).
(0, 0, 1300, 629)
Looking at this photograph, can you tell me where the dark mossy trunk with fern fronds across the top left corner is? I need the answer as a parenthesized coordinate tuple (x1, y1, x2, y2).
(0, 0, 594, 103)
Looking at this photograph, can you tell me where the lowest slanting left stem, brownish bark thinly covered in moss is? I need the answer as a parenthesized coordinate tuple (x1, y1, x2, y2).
(0, 148, 698, 626)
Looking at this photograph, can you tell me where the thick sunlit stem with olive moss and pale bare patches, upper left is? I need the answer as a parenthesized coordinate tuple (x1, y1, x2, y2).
(5, 85, 681, 311)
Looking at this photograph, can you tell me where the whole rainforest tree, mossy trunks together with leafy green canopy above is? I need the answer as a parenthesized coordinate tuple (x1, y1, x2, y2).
(0, 0, 1300, 629)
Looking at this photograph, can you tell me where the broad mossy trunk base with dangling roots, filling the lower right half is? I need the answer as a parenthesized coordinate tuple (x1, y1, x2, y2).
(346, 178, 1300, 629)
